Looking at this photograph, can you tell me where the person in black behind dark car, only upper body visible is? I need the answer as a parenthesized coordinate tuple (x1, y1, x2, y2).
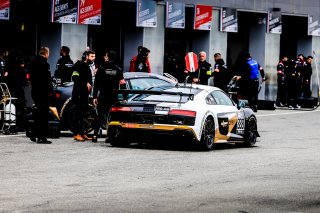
(54, 46, 73, 83)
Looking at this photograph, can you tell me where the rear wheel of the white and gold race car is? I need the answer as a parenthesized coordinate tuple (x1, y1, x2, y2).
(200, 116, 215, 151)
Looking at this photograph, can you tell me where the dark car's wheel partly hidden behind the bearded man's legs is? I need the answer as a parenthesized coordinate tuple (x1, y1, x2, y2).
(61, 98, 97, 134)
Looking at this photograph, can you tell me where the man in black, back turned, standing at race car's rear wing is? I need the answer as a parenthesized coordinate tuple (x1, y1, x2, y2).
(92, 51, 127, 142)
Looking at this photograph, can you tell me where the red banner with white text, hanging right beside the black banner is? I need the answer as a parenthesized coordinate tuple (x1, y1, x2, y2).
(78, 0, 102, 25)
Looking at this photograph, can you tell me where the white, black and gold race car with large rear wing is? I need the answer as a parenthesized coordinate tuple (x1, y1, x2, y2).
(106, 84, 259, 150)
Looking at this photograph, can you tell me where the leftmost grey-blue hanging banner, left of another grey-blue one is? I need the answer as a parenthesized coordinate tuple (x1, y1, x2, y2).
(136, 0, 157, 27)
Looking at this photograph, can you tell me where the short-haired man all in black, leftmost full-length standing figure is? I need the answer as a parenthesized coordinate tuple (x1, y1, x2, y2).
(30, 47, 53, 144)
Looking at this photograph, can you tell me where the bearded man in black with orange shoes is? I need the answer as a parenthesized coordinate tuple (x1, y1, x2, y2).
(72, 50, 96, 141)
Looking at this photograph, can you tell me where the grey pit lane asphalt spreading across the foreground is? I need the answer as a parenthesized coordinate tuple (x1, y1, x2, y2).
(0, 110, 320, 212)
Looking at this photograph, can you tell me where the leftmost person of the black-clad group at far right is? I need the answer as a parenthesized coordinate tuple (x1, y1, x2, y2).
(276, 55, 288, 107)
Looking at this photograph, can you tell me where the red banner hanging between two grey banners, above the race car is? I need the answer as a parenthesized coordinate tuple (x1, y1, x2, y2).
(194, 5, 212, 30)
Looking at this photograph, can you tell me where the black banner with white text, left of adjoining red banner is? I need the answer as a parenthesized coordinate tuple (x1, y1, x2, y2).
(52, 0, 78, 24)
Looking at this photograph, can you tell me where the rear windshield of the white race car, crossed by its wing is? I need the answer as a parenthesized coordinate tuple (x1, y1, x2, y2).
(132, 87, 201, 103)
